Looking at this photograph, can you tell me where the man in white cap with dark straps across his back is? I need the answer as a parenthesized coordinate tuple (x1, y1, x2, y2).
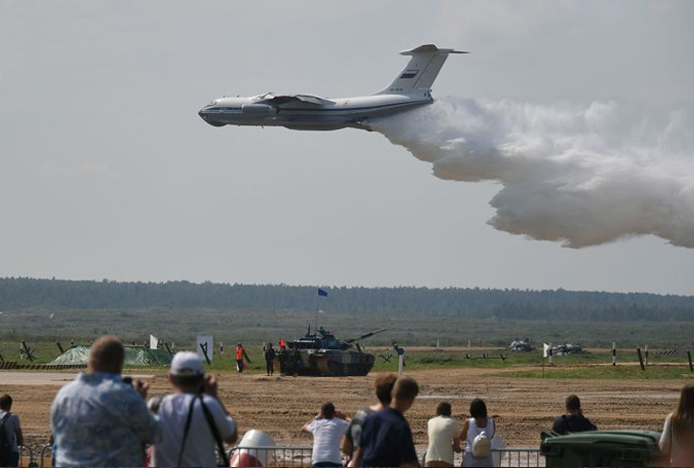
(152, 351, 237, 466)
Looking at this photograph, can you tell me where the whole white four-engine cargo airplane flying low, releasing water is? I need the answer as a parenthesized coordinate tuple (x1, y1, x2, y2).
(198, 44, 468, 131)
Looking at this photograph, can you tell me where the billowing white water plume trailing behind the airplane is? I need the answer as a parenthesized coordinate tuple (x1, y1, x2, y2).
(372, 98, 694, 248)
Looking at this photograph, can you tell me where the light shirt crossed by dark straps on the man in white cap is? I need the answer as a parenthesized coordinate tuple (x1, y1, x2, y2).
(151, 393, 236, 466)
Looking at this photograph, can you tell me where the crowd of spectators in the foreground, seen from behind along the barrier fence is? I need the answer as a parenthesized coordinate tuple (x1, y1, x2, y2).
(0, 336, 694, 467)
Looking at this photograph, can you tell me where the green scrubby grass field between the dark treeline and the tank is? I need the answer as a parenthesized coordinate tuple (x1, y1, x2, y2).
(0, 307, 694, 349)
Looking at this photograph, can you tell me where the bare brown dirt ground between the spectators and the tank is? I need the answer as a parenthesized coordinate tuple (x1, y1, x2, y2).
(0, 368, 682, 456)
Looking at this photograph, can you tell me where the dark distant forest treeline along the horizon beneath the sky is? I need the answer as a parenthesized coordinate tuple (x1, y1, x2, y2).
(0, 278, 694, 322)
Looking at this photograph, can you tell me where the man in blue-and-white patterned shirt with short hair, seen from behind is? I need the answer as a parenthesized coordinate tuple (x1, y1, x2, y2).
(51, 336, 161, 466)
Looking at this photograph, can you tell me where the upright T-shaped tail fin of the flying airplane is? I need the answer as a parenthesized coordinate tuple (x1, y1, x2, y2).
(376, 44, 469, 94)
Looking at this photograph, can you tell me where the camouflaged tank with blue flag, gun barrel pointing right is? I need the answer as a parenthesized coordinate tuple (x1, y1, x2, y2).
(280, 327, 386, 377)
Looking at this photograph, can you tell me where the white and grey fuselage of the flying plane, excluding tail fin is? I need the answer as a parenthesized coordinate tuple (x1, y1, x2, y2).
(199, 92, 433, 130)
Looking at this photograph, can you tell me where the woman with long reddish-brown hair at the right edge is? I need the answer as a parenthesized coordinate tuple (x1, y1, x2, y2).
(659, 384, 694, 466)
